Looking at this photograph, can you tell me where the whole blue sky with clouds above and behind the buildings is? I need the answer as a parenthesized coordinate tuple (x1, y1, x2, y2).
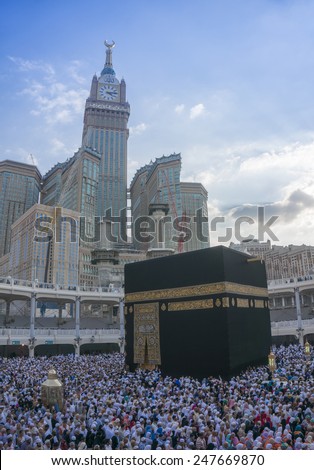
(0, 0, 314, 248)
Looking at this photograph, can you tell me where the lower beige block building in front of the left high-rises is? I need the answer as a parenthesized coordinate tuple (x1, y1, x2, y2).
(9, 204, 80, 286)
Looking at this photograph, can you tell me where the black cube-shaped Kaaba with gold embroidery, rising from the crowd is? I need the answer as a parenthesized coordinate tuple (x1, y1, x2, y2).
(125, 246, 271, 378)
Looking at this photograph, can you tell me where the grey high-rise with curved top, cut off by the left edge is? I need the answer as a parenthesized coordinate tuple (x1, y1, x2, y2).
(0, 160, 41, 256)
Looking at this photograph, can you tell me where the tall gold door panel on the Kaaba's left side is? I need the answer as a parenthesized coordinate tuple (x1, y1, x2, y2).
(134, 302, 161, 369)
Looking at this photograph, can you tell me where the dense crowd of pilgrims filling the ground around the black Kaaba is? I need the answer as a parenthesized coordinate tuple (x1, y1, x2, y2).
(0, 345, 314, 450)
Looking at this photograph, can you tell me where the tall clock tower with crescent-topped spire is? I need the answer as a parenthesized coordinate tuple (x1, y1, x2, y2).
(82, 41, 130, 241)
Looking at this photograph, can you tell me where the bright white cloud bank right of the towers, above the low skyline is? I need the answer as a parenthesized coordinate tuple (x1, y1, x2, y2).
(183, 140, 314, 246)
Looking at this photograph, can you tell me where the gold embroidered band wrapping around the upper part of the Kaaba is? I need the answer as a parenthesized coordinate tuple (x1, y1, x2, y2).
(125, 282, 268, 303)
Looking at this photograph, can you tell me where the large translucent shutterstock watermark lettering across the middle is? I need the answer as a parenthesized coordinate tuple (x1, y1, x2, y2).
(34, 206, 279, 246)
